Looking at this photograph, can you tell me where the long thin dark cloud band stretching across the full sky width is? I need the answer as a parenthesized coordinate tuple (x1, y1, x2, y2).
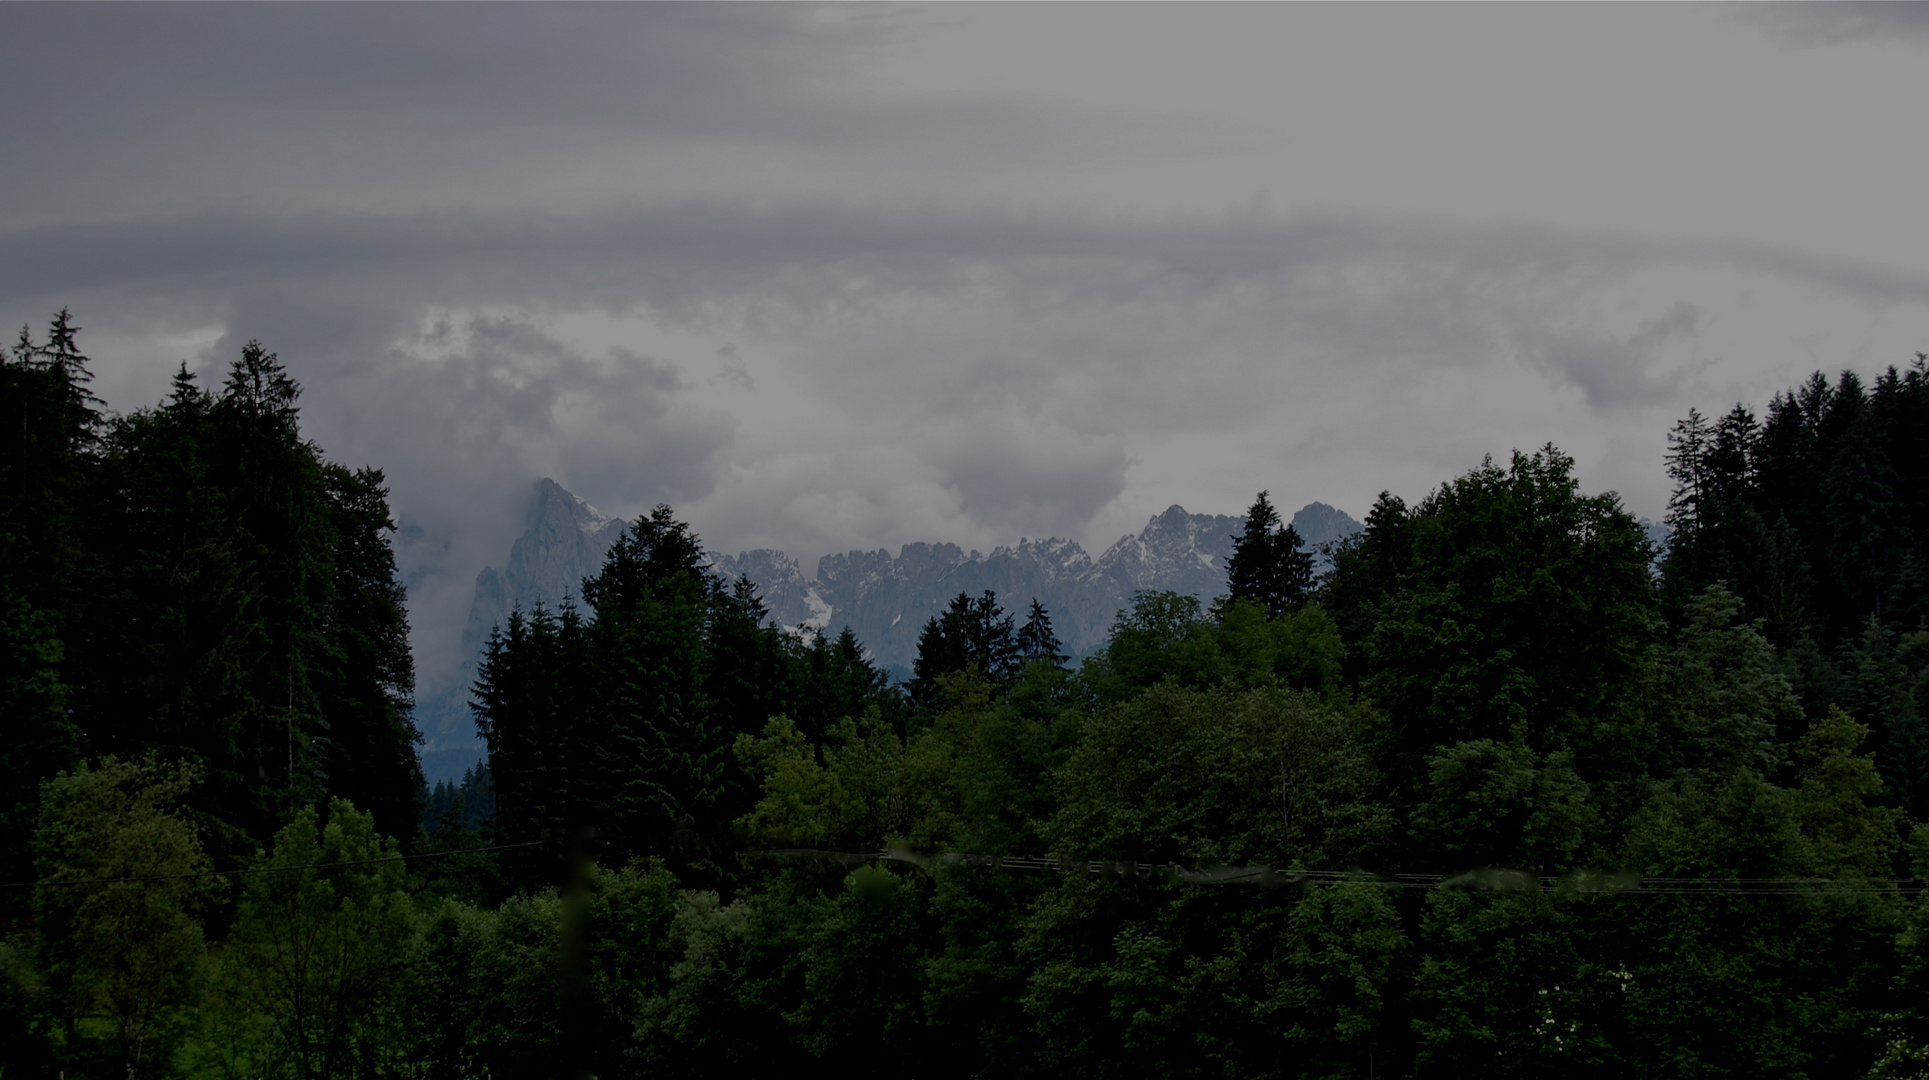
(15, 201, 1929, 326)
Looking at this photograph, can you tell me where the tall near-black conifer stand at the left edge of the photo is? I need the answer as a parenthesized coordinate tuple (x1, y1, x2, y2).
(0, 312, 421, 878)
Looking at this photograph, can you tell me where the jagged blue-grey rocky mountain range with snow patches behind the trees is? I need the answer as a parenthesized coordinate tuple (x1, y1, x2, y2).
(417, 478, 1360, 781)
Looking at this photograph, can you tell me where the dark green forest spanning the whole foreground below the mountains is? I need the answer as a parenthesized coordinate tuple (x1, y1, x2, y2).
(18, 312, 1929, 1080)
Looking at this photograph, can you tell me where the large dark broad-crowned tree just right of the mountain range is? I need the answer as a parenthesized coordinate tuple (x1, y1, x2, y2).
(1331, 447, 1659, 825)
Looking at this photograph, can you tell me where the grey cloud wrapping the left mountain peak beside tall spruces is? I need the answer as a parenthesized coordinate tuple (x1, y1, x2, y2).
(165, 289, 735, 679)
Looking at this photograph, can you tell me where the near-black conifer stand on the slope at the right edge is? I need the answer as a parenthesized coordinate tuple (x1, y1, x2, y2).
(1663, 355, 1929, 814)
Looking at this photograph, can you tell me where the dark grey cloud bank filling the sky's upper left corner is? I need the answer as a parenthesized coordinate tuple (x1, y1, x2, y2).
(0, 4, 1149, 226)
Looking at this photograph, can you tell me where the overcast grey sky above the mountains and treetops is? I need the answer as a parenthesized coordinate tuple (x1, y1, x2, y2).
(0, 4, 1929, 679)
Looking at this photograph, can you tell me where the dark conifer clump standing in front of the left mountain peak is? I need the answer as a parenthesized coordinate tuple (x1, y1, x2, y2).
(475, 505, 901, 889)
